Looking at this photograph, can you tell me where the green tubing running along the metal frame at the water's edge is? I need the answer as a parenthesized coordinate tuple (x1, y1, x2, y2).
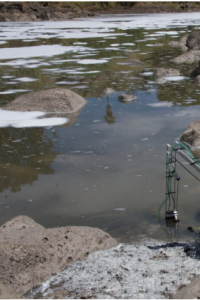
(158, 142, 200, 218)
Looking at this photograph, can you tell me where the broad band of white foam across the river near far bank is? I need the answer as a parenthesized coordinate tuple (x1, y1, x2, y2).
(0, 12, 200, 45)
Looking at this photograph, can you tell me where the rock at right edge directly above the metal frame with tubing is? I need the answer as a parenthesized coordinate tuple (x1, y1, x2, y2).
(180, 120, 200, 147)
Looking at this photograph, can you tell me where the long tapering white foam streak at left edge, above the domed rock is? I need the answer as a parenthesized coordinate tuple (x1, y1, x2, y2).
(0, 45, 93, 60)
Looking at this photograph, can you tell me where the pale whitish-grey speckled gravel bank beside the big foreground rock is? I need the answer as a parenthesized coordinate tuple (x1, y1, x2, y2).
(26, 241, 200, 299)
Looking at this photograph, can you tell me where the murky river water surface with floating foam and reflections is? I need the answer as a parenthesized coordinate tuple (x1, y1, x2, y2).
(0, 13, 200, 242)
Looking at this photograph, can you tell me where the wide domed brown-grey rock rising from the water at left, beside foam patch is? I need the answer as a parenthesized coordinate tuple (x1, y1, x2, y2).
(2, 88, 86, 112)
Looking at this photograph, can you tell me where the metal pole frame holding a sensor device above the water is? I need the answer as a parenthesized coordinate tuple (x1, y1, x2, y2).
(165, 142, 200, 222)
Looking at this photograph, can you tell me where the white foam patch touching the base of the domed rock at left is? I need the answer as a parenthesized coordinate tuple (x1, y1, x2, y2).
(0, 109, 69, 128)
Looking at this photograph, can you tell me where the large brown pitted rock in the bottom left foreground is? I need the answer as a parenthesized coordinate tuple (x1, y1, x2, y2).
(0, 216, 117, 298)
